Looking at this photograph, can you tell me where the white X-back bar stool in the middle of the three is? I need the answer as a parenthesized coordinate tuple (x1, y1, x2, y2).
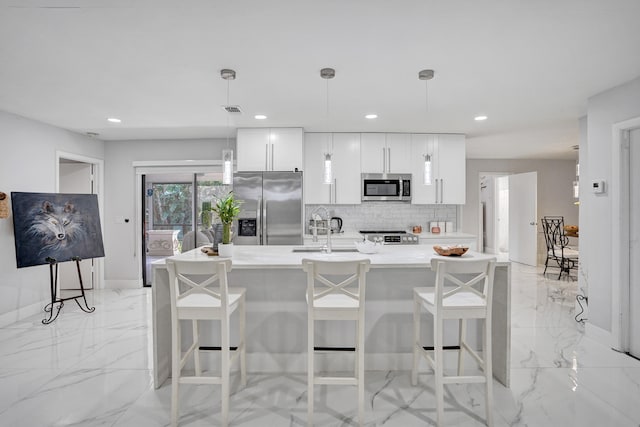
(302, 259, 370, 426)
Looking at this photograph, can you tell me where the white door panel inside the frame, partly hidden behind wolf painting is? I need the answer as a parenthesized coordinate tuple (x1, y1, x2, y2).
(58, 162, 93, 289)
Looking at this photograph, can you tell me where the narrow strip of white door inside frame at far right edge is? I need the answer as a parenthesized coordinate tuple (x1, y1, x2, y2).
(629, 129, 640, 357)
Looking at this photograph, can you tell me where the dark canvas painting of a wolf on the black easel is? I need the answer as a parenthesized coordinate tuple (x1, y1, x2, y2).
(11, 192, 104, 268)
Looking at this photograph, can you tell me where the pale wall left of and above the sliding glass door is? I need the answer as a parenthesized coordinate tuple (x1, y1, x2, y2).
(104, 139, 235, 286)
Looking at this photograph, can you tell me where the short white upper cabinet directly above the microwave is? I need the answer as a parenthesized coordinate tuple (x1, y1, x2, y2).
(360, 133, 411, 173)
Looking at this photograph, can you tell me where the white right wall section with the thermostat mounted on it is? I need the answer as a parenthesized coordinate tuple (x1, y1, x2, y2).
(580, 77, 640, 332)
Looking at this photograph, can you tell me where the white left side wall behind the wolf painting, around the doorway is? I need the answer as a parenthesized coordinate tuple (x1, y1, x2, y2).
(0, 111, 104, 324)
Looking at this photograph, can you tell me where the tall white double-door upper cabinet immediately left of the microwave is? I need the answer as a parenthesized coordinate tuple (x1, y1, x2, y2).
(303, 133, 360, 205)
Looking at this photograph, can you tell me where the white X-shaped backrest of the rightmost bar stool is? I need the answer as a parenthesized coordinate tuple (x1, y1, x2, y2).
(431, 258, 496, 310)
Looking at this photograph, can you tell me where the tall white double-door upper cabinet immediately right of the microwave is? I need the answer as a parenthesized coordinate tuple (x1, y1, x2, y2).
(411, 134, 466, 205)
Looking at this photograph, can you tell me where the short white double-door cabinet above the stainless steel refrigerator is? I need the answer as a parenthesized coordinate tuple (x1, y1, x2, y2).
(236, 128, 304, 171)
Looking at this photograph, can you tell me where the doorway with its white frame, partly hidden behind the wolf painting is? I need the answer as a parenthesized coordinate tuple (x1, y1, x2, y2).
(56, 152, 103, 290)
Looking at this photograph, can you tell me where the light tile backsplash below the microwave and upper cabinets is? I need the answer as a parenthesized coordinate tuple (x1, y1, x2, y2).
(304, 202, 458, 231)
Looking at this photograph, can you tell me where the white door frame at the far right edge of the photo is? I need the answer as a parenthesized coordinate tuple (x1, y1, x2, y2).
(610, 117, 640, 352)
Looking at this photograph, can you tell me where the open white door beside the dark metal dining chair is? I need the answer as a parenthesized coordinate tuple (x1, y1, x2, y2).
(509, 172, 538, 266)
